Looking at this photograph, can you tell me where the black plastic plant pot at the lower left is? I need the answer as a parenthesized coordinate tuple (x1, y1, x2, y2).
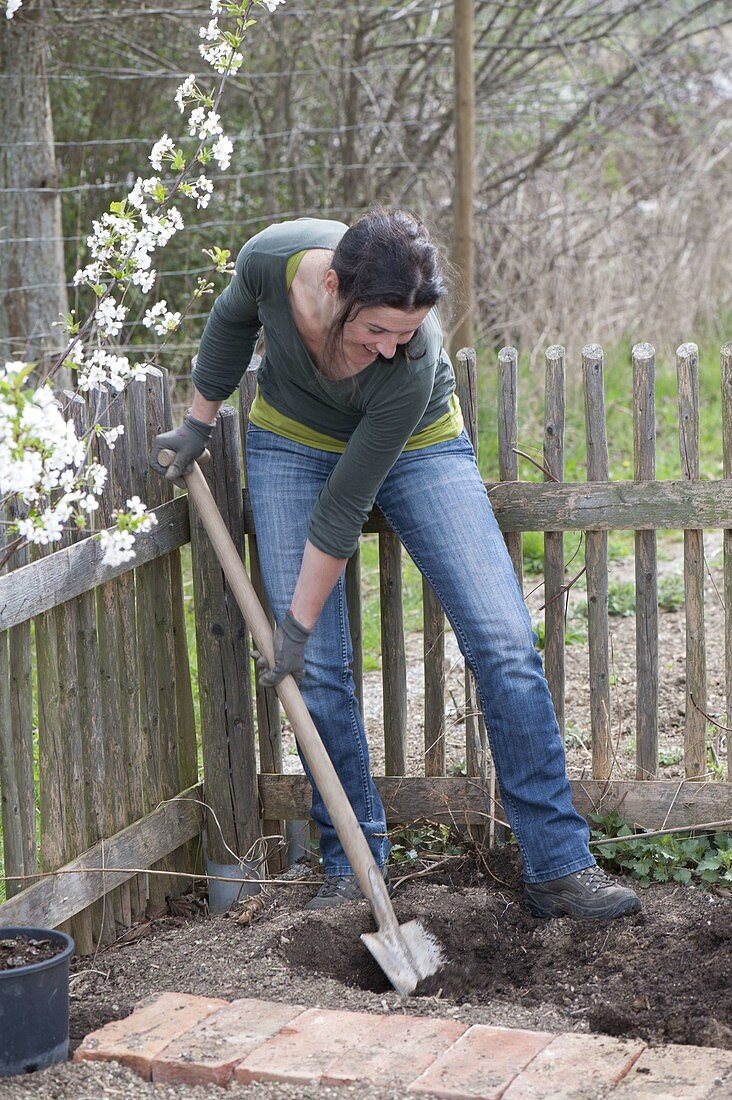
(0, 927, 74, 1077)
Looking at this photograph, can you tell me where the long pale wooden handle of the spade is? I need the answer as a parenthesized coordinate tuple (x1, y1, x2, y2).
(159, 451, 398, 928)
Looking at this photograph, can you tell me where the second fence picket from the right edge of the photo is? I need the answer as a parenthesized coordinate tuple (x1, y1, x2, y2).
(676, 343, 707, 779)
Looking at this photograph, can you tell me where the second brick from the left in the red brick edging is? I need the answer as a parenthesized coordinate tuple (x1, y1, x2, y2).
(152, 998, 305, 1085)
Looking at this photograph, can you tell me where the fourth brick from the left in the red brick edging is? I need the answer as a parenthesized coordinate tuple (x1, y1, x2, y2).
(320, 1015, 467, 1087)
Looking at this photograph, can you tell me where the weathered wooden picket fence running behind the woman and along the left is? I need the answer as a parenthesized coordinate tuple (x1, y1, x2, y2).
(0, 343, 732, 953)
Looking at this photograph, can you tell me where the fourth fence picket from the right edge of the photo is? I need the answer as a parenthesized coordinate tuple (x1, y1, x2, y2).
(582, 344, 613, 779)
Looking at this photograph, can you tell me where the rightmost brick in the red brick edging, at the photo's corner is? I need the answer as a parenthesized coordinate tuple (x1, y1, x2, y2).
(612, 1045, 732, 1100)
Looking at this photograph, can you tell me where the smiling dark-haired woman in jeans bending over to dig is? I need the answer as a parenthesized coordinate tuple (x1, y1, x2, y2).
(152, 208, 641, 919)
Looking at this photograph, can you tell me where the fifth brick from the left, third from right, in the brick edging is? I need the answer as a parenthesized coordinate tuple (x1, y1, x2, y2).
(407, 1024, 554, 1100)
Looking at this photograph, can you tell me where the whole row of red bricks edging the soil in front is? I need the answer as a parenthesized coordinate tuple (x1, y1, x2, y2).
(74, 993, 732, 1100)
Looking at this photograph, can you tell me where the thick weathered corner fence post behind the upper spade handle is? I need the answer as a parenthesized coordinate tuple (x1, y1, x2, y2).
(190, 405, 261, 865)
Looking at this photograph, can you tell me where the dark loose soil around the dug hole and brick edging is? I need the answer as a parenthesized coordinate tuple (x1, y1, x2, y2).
(0, 845, 732, 1100)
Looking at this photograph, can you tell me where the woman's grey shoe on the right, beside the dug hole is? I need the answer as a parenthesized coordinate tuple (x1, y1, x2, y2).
(524, 867, 643, 921)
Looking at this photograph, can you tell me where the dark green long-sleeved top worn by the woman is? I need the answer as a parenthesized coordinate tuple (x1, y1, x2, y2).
(193, 218, 459, 558)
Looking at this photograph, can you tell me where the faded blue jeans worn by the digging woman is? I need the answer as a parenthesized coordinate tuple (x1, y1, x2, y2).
(247, 425, 594, 882)
